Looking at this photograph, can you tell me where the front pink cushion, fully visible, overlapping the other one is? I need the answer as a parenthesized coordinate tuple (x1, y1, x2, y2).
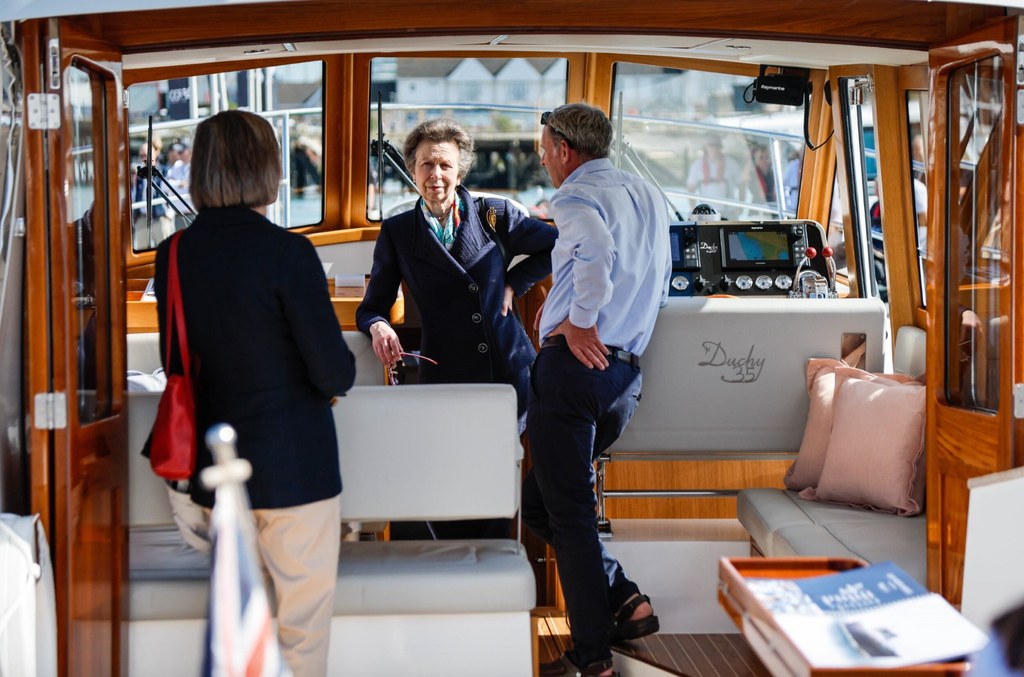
(800, 367, 925, 515)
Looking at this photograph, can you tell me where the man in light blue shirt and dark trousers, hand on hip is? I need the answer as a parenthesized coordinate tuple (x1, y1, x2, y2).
(522, 103, 672, 677)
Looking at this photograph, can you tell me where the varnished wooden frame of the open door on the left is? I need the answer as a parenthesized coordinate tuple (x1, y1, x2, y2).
(20, 19, 128, 676)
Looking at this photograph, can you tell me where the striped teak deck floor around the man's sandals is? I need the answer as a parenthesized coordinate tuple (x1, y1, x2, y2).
(534, 607, 771, 677)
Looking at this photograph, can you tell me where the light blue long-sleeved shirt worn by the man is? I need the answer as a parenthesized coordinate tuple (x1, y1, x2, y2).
(541, 158, 672, 354)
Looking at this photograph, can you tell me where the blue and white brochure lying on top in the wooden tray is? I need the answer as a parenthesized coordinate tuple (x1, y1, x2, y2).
(746, 562, 988, 668)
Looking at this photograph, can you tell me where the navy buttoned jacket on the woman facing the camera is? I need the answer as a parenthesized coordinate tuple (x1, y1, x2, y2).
(355, 185, 558, 383)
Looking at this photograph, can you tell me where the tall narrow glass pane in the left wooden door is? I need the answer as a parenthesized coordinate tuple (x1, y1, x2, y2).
(66, 65, 113, 423)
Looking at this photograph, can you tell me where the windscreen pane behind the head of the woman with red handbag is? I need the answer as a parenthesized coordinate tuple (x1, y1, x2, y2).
(128, 60, 324, 251)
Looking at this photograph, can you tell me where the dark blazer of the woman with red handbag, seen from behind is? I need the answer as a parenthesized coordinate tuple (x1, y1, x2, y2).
(156, 207, 355, 508)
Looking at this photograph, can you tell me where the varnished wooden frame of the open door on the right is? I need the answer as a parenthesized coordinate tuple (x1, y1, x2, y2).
(926, 17, 1024, 604)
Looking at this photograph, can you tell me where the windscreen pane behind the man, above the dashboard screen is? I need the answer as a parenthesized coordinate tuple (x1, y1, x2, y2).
(611, 62, 804, 220)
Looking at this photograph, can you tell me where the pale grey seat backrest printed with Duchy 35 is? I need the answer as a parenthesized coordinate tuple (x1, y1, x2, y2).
(610, 297, 885, 454)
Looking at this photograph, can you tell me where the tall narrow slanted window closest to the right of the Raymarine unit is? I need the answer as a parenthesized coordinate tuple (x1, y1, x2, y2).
(833, 77, 876, 301)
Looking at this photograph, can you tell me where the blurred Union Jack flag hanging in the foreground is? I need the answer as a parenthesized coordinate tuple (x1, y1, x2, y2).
(203, 467, 292, 677)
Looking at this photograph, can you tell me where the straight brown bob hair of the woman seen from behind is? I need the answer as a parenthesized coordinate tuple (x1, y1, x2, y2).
(188, 111, 282, 209)
